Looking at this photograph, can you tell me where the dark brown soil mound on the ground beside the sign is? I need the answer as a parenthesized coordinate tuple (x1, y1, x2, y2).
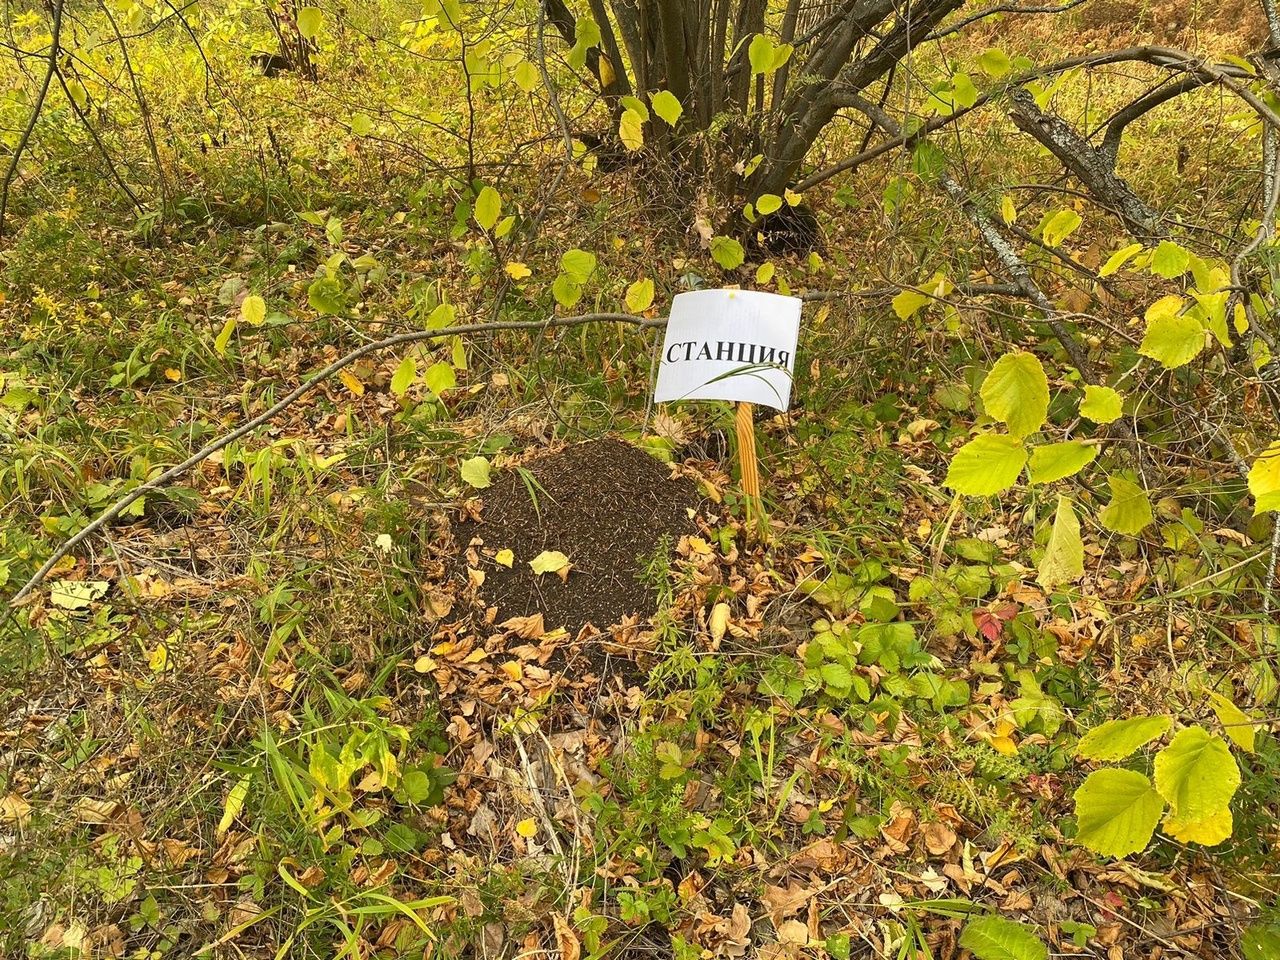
(453, 440, 699, 635)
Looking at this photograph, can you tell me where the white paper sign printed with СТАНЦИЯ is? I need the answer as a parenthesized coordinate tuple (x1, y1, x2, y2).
(653, 291, 800, 410)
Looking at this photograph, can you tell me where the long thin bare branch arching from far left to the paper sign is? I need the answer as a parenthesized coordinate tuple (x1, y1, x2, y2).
(9, 314, 667, 605)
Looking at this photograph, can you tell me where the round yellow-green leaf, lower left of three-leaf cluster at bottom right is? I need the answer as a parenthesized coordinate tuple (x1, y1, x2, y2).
(1074, 768, 1165, 856)
